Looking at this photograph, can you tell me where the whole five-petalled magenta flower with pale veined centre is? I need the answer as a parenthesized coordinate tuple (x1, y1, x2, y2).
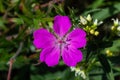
(33, 15, 86, 66)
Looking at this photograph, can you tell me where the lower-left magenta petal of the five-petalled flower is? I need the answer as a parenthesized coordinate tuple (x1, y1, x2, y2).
(40, 47, 60, 66)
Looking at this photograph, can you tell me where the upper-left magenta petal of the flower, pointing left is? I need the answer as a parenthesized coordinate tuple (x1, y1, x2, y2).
(33, 29, 55, 49)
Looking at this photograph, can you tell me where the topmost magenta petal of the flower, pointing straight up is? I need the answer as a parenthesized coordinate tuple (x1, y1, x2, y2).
(53, 15, 71, 37)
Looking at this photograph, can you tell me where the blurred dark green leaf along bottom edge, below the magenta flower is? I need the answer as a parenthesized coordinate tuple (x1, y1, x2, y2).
(31, 69, 75, 80)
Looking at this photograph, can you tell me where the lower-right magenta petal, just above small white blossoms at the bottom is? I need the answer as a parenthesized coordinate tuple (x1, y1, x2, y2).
(62, 48, 83, 66)
